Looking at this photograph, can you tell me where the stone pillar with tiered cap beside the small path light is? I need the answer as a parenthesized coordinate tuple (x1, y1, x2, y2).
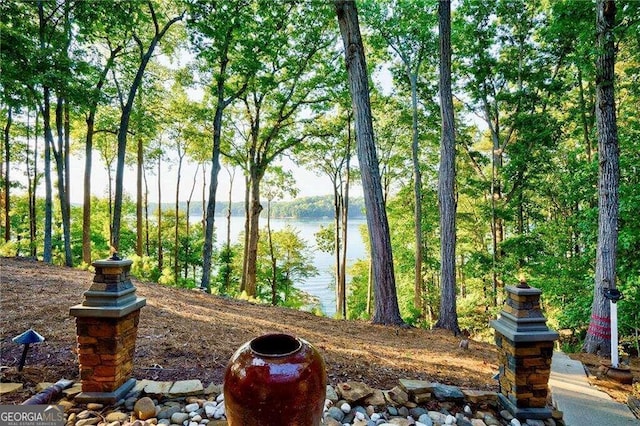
(69, 256, 146, 403)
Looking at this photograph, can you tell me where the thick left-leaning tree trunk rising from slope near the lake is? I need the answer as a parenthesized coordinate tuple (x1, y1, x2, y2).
(334, 0, 404, 324)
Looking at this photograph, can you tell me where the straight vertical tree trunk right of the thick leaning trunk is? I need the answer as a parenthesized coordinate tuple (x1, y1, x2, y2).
(435, 0, 460, 334)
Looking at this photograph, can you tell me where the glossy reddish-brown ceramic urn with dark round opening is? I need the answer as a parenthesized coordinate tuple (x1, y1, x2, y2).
(224, 334, 327, 426)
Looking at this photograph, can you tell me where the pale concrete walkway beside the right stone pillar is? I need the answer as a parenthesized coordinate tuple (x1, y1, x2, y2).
(549, 352, 640, 426)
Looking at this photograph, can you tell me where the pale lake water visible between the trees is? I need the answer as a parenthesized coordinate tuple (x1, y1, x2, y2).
(215, 216, 367, 317)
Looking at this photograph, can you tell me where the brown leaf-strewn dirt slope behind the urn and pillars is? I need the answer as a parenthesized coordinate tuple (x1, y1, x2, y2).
(0, 258, 497, 402)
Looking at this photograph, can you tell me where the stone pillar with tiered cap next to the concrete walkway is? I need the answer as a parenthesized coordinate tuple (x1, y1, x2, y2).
(491, 282, 558, 420)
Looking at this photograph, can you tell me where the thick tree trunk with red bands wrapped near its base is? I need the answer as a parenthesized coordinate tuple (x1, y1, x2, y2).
(583, 0, 620, 355)
